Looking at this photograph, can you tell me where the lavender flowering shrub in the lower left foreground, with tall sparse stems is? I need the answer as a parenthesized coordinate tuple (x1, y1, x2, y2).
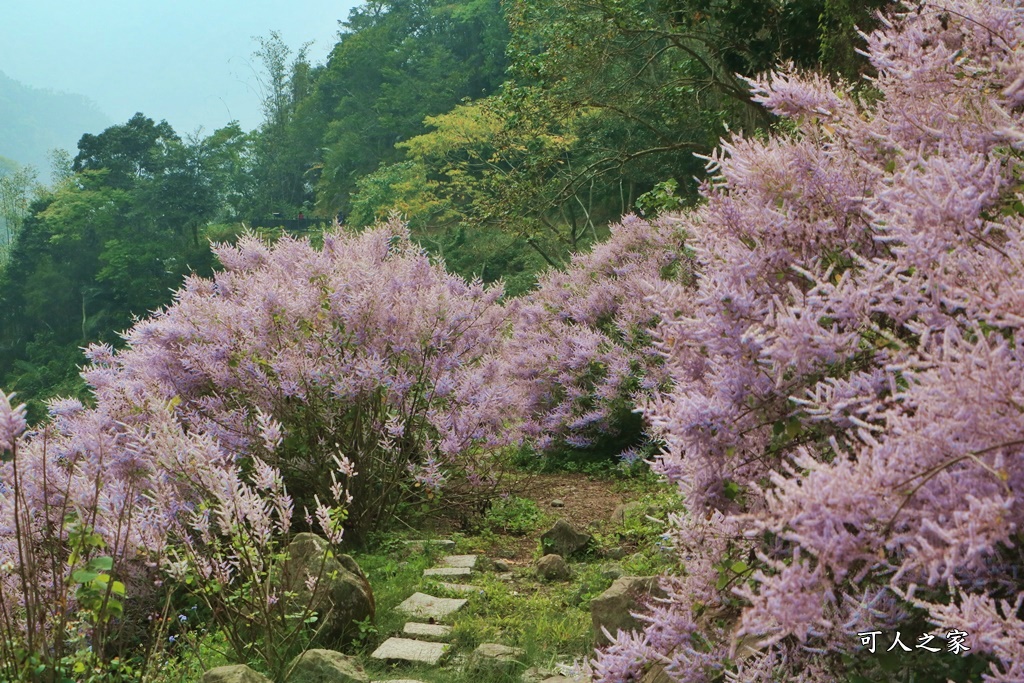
(0, 387, 357, 681)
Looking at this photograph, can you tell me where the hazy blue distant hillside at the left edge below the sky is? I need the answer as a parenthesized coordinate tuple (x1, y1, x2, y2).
(0, 73, 112, 175)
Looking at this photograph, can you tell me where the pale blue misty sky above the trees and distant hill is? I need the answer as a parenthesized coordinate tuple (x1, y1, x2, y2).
(0, 0, 359, 134)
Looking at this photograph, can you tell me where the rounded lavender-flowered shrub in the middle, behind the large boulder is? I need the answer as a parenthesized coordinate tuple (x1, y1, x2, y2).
(84, 223, 515, 536)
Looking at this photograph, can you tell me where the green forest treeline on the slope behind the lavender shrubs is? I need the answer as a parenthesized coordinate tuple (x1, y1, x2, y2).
(0, 0, 886, 419)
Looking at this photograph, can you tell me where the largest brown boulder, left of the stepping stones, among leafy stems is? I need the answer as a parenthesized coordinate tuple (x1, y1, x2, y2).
(282, 533, 376, 645)
